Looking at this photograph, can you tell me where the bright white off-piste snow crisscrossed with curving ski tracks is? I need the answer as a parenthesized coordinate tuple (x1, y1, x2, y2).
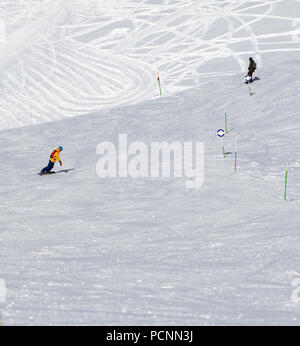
(0, 0, 300, 129)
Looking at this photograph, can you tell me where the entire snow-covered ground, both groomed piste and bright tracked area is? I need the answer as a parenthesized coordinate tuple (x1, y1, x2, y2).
(0, 0, 300, 325)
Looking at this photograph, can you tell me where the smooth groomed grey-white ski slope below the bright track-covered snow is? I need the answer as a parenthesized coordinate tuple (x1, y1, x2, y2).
(0, 60, 300, 325)
